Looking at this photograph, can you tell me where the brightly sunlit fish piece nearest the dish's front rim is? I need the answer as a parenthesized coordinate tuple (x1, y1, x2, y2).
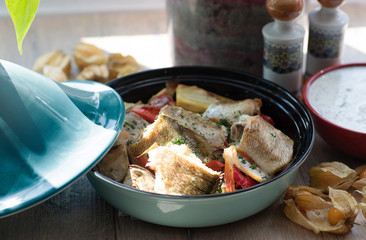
(147, 144, 220, 195)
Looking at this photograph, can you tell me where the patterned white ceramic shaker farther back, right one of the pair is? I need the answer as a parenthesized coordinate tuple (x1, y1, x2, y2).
(305, 0, 349, 78)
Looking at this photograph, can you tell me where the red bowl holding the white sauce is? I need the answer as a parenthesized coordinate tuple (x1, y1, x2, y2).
(303, 63, 366, 160)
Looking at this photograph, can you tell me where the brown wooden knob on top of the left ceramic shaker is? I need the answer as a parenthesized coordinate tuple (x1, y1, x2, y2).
(266, 0, 304, 21)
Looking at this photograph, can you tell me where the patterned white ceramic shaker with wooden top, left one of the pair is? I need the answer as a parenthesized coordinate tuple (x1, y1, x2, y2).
(262, 0, 305, 94)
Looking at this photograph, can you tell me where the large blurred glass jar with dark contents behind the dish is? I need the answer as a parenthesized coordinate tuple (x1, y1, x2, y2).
(167, 0, 272, 76)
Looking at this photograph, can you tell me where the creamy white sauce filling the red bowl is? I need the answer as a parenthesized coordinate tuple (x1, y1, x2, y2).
(308, 66, 366, 133)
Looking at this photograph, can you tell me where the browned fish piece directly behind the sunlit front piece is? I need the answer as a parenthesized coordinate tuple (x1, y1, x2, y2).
(128, 114, 216, 164)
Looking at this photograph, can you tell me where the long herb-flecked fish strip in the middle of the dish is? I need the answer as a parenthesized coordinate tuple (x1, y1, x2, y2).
(160, 105, 228, 149)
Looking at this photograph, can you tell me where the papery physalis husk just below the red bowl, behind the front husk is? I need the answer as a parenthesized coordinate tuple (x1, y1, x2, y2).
(309, 162, 357, 192)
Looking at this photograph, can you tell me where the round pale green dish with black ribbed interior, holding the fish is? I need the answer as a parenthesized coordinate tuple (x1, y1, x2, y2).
(87, 67, 314, 227)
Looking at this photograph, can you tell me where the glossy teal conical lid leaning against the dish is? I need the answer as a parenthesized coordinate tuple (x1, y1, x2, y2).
(0, 60, 125, 217)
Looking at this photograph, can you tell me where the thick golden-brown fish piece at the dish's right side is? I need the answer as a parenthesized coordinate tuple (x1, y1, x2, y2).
(231, 116, 294, 175)
